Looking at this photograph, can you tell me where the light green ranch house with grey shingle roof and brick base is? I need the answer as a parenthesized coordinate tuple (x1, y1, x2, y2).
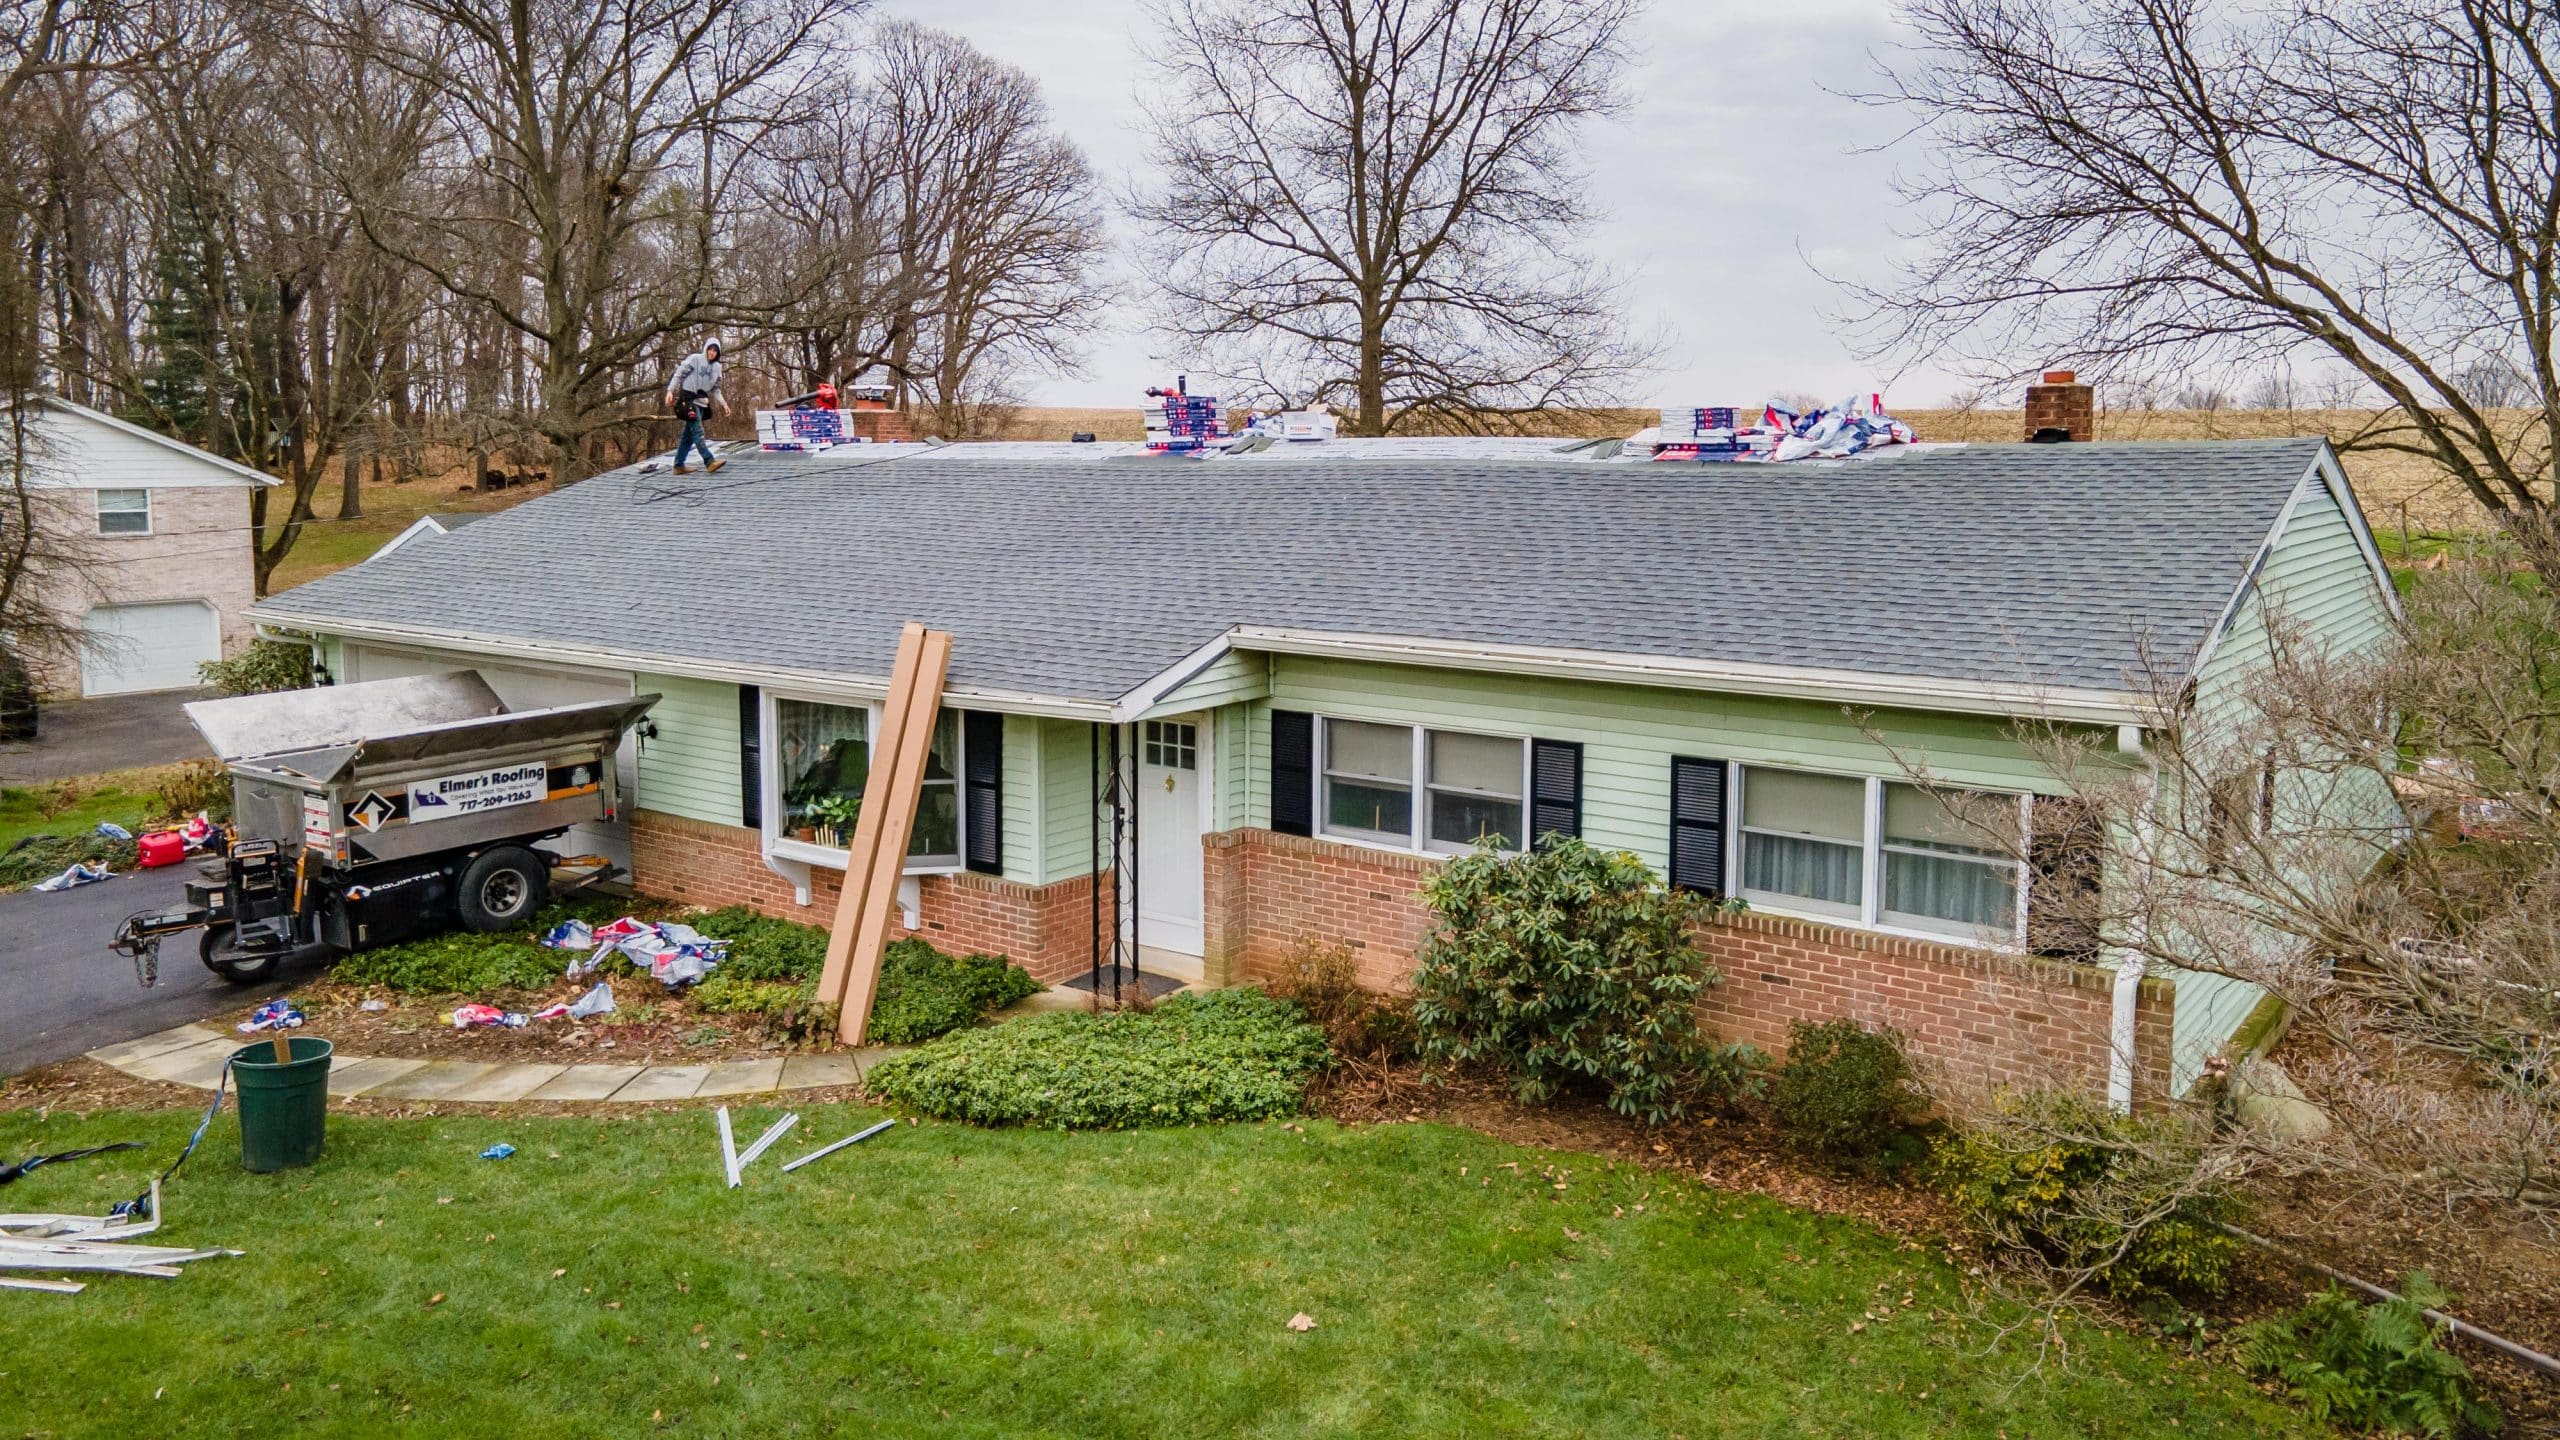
(253, 438, 2396, 1102)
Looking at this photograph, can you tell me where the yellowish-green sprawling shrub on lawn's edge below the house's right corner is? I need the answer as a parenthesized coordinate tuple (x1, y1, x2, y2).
(1933, 1089, 2240, 1299)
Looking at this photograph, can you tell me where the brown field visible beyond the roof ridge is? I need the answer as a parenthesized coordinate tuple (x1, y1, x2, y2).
(998, 405, 2483, 530)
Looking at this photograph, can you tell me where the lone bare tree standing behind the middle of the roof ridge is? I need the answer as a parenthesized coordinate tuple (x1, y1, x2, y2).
(1129, 0, 1649, 436)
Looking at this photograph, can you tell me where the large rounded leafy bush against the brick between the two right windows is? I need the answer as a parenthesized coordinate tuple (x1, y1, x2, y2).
(1413, 838, 1741, 1125)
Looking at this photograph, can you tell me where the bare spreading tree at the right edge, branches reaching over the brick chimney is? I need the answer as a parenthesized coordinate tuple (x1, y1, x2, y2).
(1861, 0, 2560, 568)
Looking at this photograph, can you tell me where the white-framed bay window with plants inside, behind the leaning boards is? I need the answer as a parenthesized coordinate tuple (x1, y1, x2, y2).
(763, 689, 965, 874)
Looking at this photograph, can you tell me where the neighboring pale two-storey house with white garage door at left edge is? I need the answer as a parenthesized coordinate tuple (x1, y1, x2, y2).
(8, 400, 276, 694)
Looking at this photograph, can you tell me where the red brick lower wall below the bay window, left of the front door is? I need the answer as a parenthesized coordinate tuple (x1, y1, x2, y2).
(632, 810, 1111, 984)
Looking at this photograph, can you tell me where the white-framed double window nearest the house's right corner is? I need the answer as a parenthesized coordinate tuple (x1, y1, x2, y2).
(1731, 766, 2028, 945)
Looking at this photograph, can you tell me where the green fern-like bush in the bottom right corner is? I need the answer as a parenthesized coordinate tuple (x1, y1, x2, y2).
(2237, 1271, 2501, 1440)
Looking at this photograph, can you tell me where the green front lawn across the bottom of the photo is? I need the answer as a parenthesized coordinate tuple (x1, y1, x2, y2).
(0, 1107, 2299, 1440)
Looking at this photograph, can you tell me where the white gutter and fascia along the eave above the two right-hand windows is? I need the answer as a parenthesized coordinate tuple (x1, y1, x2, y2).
(1231, 625, 2156, 725)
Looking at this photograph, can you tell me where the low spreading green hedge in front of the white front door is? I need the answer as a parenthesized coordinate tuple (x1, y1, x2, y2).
(870, 989, 1326, 1130)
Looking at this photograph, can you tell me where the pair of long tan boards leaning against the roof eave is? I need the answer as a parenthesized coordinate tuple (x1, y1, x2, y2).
(819, 625, 952, 1045)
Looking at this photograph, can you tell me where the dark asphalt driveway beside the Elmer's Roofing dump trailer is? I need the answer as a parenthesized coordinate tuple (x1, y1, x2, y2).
(0, 866, 317, 1076)
